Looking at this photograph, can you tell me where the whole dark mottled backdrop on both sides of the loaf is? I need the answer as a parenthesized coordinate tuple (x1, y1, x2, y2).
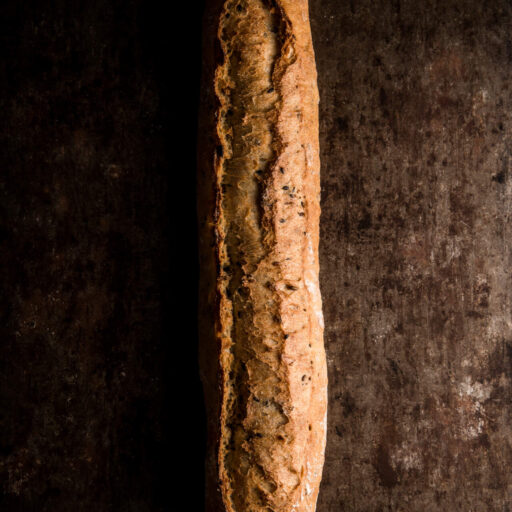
(0, 0, 512, 512)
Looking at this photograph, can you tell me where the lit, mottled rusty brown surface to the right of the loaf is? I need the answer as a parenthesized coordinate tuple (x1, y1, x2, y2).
(310, 0, 512, 512)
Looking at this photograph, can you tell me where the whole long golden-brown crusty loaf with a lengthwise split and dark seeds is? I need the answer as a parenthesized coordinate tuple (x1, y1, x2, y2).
(198, 0, 327, 512)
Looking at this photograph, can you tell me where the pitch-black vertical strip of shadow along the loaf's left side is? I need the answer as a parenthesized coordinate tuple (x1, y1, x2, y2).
(139, 1, 206, 511)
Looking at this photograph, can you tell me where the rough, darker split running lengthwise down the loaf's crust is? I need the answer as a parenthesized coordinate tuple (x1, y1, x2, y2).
(217, 1, 289, 512)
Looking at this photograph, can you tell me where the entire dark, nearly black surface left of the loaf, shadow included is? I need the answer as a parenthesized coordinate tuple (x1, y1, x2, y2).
(0, 0, 205, 512)
